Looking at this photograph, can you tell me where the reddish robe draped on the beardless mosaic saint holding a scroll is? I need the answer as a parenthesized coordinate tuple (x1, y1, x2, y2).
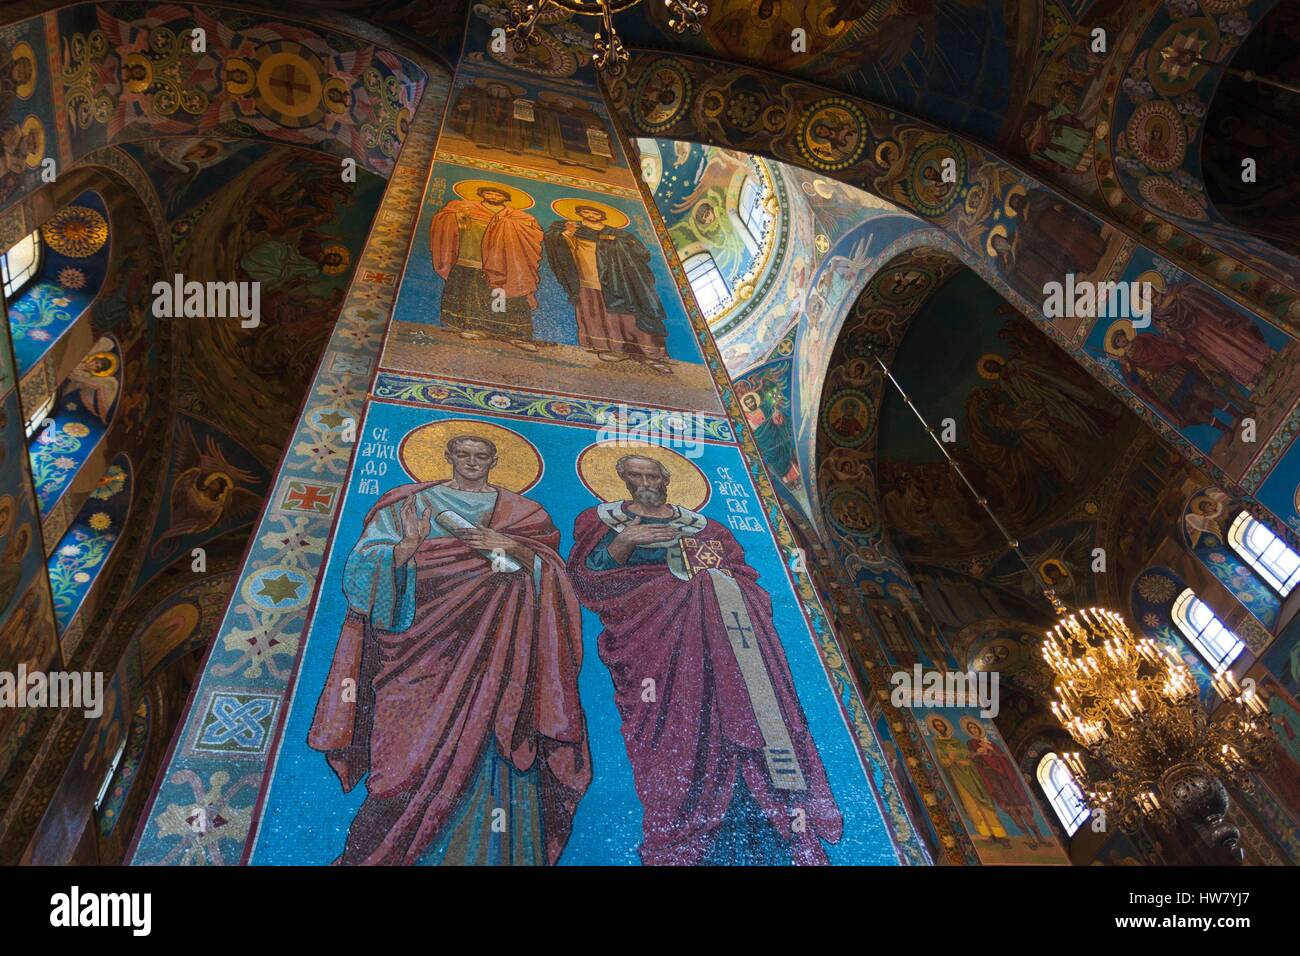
(308, 481, 592, 864)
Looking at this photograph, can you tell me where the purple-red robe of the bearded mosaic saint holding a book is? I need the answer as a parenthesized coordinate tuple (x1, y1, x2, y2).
(568, 509, 844, 865)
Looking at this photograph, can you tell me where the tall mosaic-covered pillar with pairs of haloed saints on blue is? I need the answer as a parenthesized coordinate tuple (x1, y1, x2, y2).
(134, 8, 928, 864)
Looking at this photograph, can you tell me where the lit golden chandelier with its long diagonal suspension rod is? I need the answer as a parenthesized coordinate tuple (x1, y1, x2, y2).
(871, 351, 1274, 861)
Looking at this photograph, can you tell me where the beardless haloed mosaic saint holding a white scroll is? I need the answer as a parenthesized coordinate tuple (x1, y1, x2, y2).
(308, 420, 592, 865)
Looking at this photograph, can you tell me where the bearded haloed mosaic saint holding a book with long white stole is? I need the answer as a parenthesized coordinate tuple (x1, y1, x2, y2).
(568, 445, 842, 865)
